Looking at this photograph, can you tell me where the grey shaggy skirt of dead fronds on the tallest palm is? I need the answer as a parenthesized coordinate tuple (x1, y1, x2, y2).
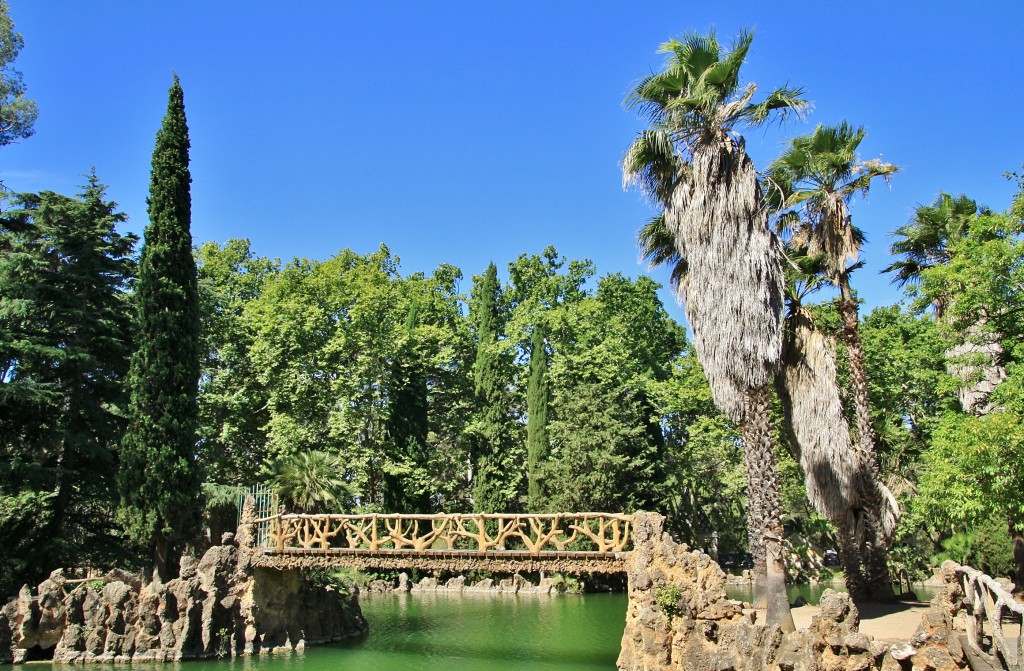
(665, 137, 784, 423)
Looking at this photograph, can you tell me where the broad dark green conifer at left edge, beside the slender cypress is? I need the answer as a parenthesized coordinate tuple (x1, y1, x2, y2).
(0, 174, 136, 594)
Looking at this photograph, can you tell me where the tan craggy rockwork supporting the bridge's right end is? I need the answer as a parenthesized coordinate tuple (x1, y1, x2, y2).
(618, 513, 967, 671)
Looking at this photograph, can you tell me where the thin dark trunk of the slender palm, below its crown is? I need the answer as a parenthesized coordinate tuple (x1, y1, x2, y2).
(839, 275, 893, 598)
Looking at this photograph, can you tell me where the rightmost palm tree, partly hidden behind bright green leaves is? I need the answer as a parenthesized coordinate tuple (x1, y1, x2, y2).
(883, 193, 1006, 415)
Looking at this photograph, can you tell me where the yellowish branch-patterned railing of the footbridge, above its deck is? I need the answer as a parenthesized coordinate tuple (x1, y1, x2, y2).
(256, 512, 633, 555)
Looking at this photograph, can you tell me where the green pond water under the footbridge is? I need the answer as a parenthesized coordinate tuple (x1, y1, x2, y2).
(68, 585, 937, 671)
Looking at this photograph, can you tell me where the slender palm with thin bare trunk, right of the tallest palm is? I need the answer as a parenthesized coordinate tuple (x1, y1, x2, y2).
(765, 121, 899, 598)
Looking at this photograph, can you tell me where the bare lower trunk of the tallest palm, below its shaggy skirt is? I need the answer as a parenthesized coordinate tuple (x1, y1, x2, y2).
(742, 385, 796, 631)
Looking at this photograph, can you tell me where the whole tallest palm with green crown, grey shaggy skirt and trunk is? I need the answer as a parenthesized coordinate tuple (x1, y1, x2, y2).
(623, 32, 807, 628)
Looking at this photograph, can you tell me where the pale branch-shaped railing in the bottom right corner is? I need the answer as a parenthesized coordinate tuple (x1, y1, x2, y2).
(955, 565, 1024, 671)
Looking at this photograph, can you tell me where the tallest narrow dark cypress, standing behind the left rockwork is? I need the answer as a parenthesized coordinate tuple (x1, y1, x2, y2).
(118, 75, 201, 579)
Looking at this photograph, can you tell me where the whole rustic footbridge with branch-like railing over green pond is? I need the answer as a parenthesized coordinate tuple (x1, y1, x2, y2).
(254, 512, 633, 573)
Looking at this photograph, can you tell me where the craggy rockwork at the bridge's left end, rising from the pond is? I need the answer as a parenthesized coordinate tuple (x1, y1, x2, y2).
(0, 512, 367, 664)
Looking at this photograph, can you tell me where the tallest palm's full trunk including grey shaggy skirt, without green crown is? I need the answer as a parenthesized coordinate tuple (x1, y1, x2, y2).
(665, 138, 793, 627)
